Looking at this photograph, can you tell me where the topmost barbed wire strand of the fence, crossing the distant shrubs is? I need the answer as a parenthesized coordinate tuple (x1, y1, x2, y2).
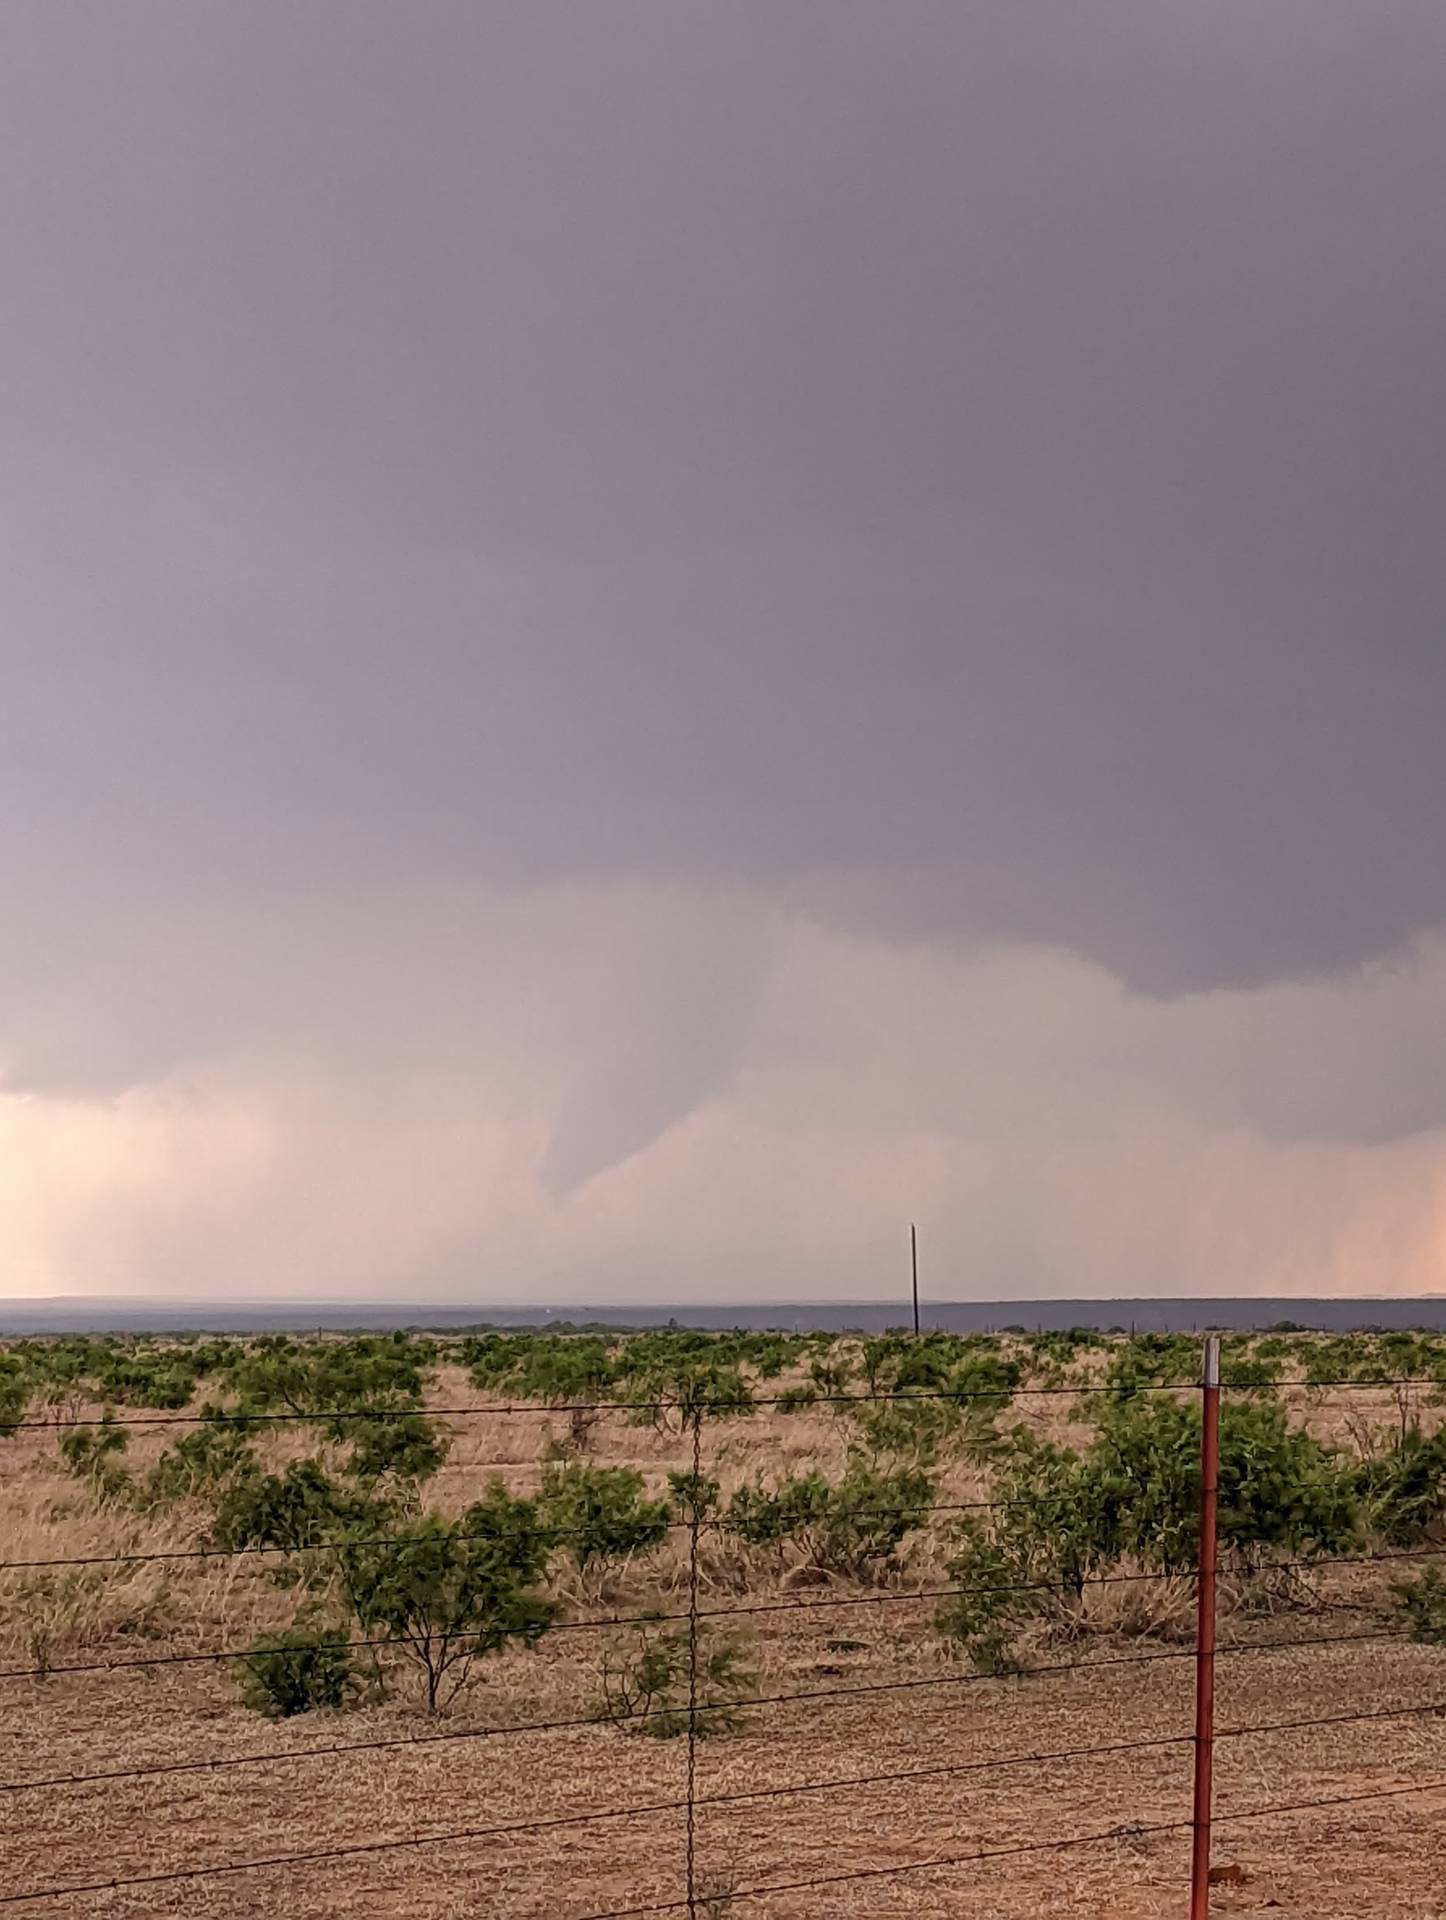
(0, 1371, 1446, 1432)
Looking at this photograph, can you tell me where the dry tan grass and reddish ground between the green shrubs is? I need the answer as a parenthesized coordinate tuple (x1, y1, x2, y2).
(0, 1336, 1446, 1920)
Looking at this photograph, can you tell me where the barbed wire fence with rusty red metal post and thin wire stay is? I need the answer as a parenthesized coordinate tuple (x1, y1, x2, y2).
(0, 1338, 1446, 1920)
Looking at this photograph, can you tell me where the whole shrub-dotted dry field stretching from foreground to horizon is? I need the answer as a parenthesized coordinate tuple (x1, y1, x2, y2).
(0, 1336, 1446, 1920)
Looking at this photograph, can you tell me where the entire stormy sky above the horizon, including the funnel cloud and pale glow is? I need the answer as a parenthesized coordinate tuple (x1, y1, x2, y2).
(0, 0, 1446, 1302)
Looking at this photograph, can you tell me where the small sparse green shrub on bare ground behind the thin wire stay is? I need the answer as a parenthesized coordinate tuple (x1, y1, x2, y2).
(593, 1620, 757, 1740)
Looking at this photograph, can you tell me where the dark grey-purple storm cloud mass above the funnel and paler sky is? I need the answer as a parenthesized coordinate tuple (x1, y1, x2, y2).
(0, 0, 1446, 1021)
